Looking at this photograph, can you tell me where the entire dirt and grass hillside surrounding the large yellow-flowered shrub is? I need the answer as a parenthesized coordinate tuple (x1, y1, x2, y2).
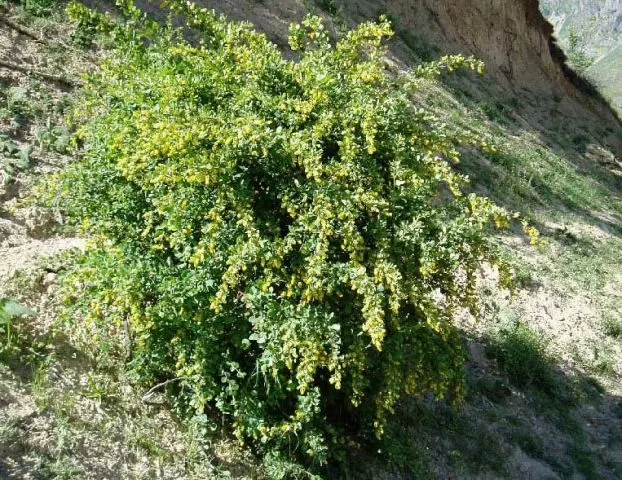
(0, 0, 622, 479)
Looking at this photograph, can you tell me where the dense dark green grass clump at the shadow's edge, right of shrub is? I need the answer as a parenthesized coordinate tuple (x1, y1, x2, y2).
(488, 323, 555, 393)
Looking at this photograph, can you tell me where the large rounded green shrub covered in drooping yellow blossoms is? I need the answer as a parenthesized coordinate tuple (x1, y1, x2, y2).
(50, 0, 532, 463)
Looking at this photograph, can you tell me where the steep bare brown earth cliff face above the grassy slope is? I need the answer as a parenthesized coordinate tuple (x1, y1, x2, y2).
(343, 0, 622, 118)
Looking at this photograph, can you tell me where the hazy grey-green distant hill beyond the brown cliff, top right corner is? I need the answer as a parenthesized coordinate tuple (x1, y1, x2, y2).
(541, 0, 622, 111)
